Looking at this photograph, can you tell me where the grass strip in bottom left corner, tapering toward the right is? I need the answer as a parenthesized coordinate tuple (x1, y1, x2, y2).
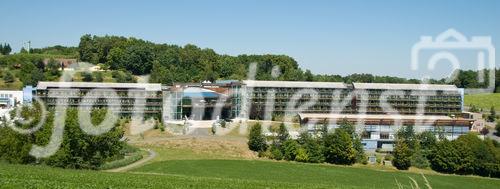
(0, 163, 312, 188)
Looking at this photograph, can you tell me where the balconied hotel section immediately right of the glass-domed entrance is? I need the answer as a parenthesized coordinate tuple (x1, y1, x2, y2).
(240, 80, 355, 120)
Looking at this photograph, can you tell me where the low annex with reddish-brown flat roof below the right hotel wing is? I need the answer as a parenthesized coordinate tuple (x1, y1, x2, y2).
(299, 113, 474, 151)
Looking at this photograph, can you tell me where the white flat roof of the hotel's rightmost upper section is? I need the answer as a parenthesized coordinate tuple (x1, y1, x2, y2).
(353, 83, 458, 91)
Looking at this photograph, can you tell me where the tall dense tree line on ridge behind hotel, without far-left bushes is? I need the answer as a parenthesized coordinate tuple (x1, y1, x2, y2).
(78, 35, 500, 91)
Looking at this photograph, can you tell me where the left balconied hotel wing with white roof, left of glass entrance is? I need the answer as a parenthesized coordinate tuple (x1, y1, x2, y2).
(36, 82, 163, 118)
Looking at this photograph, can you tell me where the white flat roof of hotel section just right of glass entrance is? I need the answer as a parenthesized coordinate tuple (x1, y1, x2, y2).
(243, 80, 347, 89)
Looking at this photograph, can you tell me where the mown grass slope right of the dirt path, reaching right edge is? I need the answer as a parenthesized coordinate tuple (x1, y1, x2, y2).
(131, 160, 500, 189)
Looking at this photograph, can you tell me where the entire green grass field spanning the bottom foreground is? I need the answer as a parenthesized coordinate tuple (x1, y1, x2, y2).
(0, 160, 500, 188)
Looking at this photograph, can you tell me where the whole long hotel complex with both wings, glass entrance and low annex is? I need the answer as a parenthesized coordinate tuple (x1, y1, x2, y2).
(35, 80, 474, 149)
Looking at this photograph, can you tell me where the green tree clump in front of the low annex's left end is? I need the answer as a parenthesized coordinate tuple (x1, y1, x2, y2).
(248, 121, 367, 165)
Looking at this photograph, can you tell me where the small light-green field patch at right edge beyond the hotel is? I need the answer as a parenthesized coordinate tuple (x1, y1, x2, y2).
(464, 93, 500, 111)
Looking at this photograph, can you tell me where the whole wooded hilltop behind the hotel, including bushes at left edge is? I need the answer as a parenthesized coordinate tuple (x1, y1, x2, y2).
(0, 34, 500, 92)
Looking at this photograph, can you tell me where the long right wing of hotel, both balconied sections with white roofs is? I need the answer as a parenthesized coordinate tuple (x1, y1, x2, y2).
(236, 81, 463, 119)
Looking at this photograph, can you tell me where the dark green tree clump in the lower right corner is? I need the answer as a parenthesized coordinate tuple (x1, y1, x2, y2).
(392, 125, 500, 178)
